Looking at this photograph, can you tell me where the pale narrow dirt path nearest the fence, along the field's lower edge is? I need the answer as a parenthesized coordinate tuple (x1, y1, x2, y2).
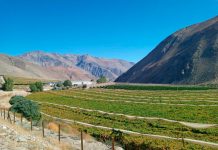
(42, 113, 218, 148)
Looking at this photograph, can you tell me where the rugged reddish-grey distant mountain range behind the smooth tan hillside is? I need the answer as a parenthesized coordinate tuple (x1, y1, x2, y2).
(19, 51, 134, 81)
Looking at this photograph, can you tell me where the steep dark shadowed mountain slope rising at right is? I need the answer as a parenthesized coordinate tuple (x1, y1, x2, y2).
(116, 16, 218, 84)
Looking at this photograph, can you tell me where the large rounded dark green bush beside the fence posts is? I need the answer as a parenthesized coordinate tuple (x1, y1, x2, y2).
(10, 96, 41, 121)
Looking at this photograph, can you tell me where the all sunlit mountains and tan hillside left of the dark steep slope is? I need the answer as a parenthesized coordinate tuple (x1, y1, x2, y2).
(0, 51, 133, 81)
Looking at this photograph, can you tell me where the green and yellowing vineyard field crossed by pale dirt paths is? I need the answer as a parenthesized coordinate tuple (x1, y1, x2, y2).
(27, 89, 218, 148)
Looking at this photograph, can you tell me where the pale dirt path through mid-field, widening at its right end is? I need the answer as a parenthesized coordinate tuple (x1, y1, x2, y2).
(38, 102, 218, 129)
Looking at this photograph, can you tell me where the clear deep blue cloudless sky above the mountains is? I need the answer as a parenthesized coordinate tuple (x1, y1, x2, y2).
(0, 0, 218, 62)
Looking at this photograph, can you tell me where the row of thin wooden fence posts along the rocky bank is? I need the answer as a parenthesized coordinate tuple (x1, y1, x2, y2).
(0, 107, 115, 150)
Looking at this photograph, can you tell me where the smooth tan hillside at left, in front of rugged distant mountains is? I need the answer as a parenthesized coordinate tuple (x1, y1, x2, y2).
(0, 54, 92, 80)
